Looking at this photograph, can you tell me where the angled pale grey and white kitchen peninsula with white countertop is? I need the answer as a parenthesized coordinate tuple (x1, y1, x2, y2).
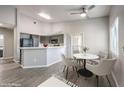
(20, 46, 65, 68)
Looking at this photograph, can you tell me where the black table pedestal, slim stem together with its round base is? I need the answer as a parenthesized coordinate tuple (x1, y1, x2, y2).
(78, 59, 93, 77)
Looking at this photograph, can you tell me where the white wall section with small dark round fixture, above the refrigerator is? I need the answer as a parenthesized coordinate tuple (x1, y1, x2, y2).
(18, 13, 51, 35)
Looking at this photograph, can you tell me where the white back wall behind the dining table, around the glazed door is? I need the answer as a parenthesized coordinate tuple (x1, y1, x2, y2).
(52, 17, 109, 55)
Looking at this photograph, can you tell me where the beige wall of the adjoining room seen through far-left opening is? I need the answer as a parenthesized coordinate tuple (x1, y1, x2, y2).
(0, 28, 14, 58)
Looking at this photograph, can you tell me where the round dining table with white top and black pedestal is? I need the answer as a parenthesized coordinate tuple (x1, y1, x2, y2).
(73, 53, 99, 77)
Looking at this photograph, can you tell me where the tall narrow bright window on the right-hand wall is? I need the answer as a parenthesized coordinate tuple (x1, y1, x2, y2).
(110, 17, 119, 56)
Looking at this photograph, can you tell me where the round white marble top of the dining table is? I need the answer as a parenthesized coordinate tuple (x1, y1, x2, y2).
(73, 53, 99, 59)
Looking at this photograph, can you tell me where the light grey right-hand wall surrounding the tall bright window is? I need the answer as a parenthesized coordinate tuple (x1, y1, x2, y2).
(109, 5, 124, 87)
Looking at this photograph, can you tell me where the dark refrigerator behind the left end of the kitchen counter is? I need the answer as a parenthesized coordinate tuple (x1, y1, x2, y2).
(20, 38, 33, 47)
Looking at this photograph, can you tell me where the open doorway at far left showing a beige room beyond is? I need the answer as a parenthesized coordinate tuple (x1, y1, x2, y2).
(0, 28, 14, 63)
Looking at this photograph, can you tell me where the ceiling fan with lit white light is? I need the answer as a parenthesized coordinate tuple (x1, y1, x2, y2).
(70, 5, 96, 18)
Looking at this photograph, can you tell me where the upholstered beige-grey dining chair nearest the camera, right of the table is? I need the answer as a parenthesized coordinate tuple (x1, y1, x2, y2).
(86, 58, 116, 86)
